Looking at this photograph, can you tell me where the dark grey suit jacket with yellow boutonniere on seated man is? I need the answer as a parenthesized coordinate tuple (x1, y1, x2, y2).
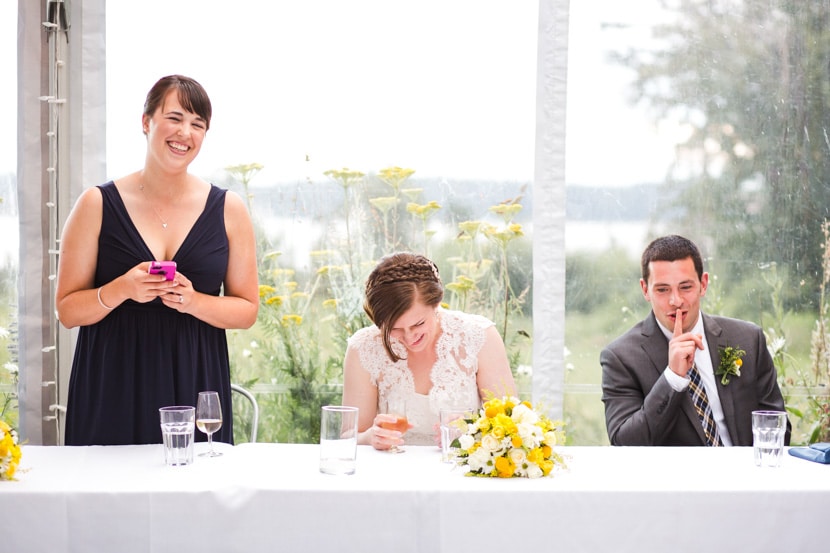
(600, 312, 790, 446)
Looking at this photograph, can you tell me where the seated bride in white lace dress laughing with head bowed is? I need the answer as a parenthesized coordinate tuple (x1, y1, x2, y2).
(343, 253, 515, 449)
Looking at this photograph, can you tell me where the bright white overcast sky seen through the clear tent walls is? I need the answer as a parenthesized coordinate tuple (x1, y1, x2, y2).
(0, 0, 671, 185)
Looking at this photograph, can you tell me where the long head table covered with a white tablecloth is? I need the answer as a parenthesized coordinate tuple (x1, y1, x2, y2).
(0, 443, 830, 553)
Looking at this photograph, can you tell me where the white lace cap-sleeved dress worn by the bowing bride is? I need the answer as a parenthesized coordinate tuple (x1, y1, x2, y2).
(349, 308, 493, 445)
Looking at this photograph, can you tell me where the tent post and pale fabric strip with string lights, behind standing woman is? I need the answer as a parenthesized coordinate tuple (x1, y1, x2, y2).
(17, 0, 106, 445)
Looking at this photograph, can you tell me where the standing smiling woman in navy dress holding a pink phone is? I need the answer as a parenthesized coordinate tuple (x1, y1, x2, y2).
(56, 75, 259, 445)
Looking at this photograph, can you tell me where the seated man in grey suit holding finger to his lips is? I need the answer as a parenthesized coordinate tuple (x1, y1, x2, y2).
(600, 236, 790, 446)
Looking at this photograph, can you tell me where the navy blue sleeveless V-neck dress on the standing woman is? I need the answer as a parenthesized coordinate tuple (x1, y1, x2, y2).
(65, 182, 233, 445)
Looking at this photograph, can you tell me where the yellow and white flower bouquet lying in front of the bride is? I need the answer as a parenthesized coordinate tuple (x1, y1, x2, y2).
(452, 396, 565, 478)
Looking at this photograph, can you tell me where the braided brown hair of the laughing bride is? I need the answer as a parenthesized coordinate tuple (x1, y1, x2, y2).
(363, 252, 444, 361)
